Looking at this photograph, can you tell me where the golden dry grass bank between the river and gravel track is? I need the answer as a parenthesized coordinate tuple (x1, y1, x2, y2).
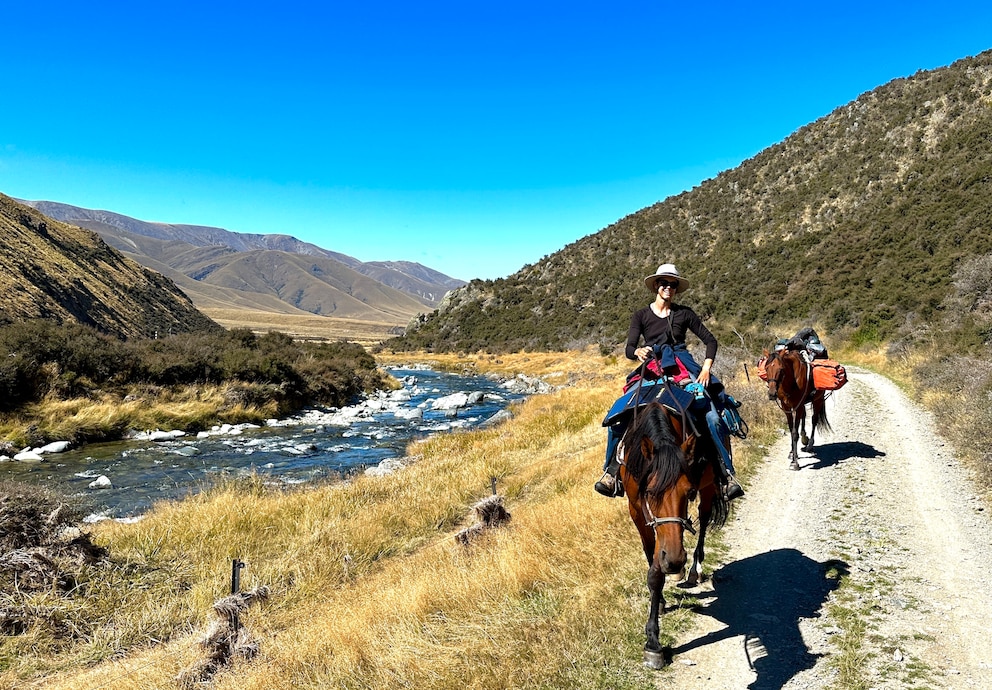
(0, 351, 780, 688)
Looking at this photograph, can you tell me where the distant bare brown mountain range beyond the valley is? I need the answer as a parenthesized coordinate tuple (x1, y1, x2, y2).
(21, 201, 465, 318)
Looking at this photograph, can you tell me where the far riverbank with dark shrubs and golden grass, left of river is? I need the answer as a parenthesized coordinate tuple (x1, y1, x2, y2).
(0, 321, 395, 454)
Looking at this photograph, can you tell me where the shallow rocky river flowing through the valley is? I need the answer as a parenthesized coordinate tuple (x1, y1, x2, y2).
(0, 368, 526, 521)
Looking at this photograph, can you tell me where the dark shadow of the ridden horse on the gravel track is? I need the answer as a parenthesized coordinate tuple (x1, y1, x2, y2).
(672, 549, 848, 690)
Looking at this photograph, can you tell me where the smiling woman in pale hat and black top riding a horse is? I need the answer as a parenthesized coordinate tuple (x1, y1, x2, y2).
(595, 264, 744, 500)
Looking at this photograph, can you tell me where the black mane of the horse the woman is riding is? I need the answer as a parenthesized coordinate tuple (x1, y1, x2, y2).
(624, 403, 688, 496)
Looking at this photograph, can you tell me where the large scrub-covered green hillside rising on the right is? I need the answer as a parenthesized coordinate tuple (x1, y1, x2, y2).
(390, 52, 992, 351)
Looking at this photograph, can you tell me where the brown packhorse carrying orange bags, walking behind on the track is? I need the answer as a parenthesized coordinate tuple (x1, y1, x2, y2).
(765, 349, 830, 470)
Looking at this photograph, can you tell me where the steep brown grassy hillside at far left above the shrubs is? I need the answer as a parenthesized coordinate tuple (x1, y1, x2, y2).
(0, 194, 220, 338)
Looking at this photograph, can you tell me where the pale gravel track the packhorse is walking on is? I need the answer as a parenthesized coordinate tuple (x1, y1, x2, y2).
(658, 369, 992, 690)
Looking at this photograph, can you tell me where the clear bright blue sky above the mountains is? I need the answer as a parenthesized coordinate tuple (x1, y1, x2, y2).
(0, 0, 992, 279)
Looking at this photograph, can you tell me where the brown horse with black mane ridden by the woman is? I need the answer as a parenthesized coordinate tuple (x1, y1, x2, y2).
(619, 402, 727, 669)
